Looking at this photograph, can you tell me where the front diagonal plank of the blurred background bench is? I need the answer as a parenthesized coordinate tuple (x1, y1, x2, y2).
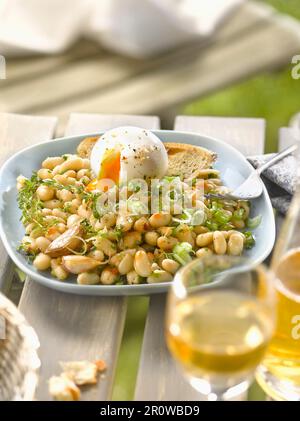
(29, 13, 300, 124)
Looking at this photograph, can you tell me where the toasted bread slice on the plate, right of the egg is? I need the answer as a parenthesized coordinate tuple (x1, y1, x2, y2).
(164, 143, 217, 180)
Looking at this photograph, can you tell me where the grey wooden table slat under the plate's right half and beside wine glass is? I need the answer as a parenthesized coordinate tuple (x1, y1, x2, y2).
(135, 116, 264, 401)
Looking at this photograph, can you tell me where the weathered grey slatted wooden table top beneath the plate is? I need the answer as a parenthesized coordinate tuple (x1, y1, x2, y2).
(0, 110, 285, 400)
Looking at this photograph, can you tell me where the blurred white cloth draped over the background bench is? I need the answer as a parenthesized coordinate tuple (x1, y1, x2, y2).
(0, 0, 245, 58)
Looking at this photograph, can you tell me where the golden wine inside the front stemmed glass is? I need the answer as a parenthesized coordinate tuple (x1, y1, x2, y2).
(167, 290, 273, 380)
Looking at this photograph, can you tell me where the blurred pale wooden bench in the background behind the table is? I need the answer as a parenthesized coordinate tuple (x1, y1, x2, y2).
(0, 1, 300, 134)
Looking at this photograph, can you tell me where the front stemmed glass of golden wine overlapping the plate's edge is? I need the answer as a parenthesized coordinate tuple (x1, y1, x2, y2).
(166, 255, 275, 400)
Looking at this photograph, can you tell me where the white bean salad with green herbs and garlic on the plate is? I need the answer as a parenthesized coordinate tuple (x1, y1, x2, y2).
(17, 142, 259, 285)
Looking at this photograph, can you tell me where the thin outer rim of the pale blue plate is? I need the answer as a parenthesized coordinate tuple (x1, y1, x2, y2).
(0, 129, 276, 296)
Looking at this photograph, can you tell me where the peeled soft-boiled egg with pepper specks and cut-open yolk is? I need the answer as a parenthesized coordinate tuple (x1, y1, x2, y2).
(91, 126, 168, 189)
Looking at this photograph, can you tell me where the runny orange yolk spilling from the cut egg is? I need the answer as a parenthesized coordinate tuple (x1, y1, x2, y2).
(86, 149, 121, 191)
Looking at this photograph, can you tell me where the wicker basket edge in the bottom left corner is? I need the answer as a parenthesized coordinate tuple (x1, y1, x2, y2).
(0, 293, 40, 401)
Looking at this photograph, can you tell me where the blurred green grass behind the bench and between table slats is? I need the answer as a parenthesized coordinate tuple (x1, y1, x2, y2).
(113, 0, 300, 400)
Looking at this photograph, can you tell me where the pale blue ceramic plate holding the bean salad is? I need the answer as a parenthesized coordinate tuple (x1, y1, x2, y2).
(0, 130, 275, 295)
